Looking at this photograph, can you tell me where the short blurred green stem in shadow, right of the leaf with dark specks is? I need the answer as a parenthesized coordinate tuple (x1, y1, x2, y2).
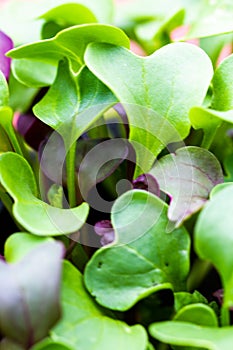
(187, 259, 212, 291)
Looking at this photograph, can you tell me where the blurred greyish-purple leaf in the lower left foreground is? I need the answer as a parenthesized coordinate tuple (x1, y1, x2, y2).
(0, 242, 63, 349)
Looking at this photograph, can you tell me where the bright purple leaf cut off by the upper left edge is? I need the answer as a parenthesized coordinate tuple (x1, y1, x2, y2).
(0, 31, 14, 79)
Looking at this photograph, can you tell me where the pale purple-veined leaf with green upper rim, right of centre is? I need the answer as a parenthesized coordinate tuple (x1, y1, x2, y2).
(151, 146, 223, 226)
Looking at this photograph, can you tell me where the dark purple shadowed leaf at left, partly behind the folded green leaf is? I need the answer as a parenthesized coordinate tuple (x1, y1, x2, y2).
(13, 113, 51, 150)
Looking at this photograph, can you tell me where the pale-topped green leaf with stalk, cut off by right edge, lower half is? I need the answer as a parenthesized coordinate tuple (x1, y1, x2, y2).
(194, 185, 233, 307)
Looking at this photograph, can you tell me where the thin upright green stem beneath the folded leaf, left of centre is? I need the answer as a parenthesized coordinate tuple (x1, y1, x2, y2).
(66, 142, 76, 208)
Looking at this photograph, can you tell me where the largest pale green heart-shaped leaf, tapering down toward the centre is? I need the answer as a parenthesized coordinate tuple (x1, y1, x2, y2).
(85, 43, 212, 177)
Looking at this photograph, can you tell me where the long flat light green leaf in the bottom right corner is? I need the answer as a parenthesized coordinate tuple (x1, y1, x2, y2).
(149, 321, 233, 350)
